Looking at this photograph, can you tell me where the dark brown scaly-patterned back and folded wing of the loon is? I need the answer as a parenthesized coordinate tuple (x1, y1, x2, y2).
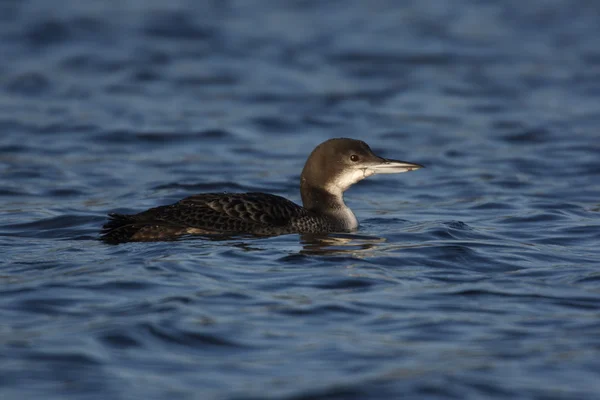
(102, 193, 307, 243)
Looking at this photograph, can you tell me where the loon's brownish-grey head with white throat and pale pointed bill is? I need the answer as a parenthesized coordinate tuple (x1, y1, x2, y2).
(300, 138, 423, 208)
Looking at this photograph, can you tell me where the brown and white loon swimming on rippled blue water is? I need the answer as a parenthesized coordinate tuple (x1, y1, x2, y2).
(101, 138, 423, 244)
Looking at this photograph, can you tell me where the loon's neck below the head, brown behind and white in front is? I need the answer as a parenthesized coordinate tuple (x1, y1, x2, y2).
(300, 180, 358, 231)
